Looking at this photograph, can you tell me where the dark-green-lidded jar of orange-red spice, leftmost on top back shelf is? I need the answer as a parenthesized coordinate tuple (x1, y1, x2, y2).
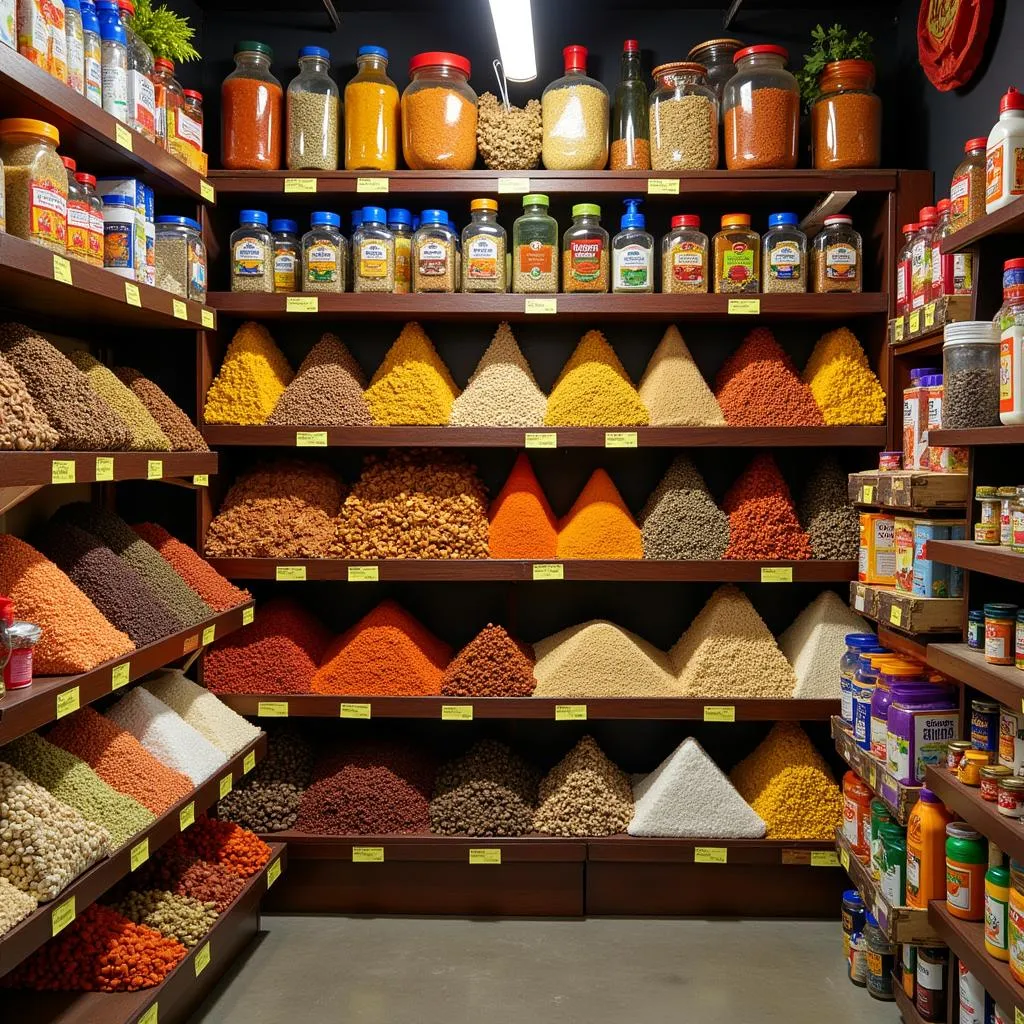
(220, 40, 285, 171)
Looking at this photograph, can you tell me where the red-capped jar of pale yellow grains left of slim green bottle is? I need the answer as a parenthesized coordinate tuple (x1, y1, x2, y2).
(541, 46, 608, 171)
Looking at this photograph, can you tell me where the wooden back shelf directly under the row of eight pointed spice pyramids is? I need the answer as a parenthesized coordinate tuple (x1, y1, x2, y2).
(203, 423, 886, 449)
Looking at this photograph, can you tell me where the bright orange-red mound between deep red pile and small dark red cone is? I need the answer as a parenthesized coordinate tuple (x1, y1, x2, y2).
(311, 600, 452, 696)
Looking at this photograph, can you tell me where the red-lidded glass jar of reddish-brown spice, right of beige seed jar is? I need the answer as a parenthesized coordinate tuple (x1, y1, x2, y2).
(722, 46, 800, 171)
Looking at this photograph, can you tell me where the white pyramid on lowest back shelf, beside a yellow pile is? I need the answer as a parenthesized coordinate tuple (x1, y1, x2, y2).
(628, 736, 765, 839)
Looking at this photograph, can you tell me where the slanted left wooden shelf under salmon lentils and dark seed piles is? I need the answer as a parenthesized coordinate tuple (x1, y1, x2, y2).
(0, 601, 253, 745)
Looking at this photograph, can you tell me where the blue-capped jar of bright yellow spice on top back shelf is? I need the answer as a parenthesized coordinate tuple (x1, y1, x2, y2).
(345, 46, 401, 171)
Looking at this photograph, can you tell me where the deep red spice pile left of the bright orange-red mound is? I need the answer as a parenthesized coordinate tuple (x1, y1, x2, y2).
(203, 598, 331, 693)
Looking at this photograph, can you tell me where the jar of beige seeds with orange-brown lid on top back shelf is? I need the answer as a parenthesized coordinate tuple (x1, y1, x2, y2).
(650, 61, 718, 171)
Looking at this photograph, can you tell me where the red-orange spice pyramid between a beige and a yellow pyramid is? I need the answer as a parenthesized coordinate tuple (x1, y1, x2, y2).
(715, 327, 824, 427)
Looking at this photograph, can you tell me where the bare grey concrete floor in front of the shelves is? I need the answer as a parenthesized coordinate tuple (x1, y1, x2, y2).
(190, 915, 899, 1024)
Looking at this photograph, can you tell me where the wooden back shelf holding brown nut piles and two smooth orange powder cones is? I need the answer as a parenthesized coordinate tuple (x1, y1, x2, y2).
(207, 558, 857, 583)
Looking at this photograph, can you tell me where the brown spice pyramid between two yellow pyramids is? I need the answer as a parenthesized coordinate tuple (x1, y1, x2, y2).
(267, 332, 371, 427)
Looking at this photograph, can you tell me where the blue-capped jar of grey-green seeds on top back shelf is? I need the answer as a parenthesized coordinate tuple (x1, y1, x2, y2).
(287, 46, 340, 171)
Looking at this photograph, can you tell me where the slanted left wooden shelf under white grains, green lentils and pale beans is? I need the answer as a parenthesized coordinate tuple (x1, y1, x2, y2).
(0, 733, 266, 978)
